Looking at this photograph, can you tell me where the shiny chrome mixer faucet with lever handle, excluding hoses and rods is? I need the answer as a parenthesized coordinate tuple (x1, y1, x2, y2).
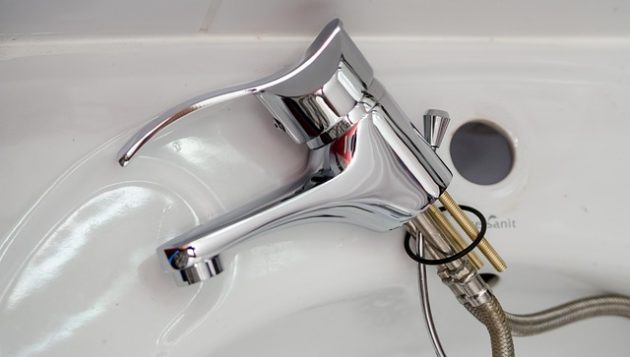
(119, 20, 452, 285)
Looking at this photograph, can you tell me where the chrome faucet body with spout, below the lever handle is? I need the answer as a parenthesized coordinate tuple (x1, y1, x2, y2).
(159, 82, 451, 284)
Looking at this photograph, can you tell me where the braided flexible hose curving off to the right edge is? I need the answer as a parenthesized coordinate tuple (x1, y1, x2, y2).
(505, 295, 630, 336)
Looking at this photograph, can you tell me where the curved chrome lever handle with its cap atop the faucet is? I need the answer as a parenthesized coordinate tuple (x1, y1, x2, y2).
(118, 19, 382, 166)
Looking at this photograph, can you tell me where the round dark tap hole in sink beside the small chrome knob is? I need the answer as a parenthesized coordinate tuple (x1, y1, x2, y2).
(450, 121, 514, 185)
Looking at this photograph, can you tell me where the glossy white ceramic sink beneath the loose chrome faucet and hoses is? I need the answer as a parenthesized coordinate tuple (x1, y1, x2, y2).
(0, 28, 630, 357)
